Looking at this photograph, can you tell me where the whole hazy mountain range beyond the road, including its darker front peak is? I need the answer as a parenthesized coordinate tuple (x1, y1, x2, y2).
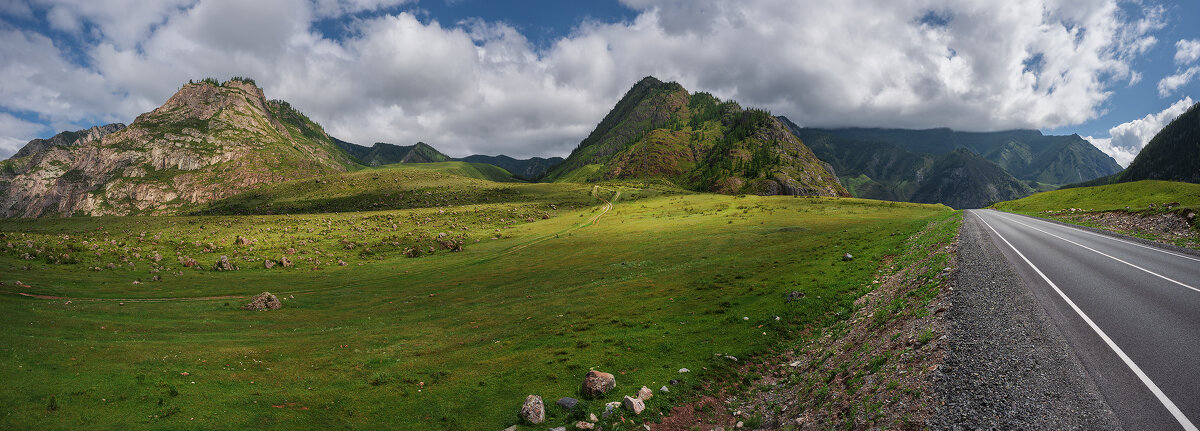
(780, 116, 1121, 208)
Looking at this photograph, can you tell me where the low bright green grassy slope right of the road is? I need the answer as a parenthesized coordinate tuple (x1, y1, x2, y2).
(994, 180, 1200, 214)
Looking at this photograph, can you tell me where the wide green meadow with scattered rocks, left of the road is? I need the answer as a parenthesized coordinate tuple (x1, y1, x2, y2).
(0, 182, 955, 430)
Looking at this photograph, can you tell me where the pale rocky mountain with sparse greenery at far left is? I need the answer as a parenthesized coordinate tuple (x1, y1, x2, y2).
(0, 78, 355, 217)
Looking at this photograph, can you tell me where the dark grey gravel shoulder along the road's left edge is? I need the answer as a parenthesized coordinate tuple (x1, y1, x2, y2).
(929, 215, 1121, 430)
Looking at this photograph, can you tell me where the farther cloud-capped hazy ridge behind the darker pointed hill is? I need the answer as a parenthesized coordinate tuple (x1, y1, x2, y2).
(801, 124, 1121, 185)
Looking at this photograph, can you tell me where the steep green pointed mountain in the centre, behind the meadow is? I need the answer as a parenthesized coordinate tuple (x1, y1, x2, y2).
(545, 77, 848, 196)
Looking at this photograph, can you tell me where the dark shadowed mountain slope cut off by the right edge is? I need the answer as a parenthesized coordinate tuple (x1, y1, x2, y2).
(1116, 103, 1200, 182)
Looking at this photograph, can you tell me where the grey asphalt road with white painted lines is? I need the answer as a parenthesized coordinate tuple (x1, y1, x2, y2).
(966, 210, 1200, 430)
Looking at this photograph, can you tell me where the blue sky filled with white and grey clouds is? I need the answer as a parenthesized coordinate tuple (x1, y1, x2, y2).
(0, 0, 1200, 164)
